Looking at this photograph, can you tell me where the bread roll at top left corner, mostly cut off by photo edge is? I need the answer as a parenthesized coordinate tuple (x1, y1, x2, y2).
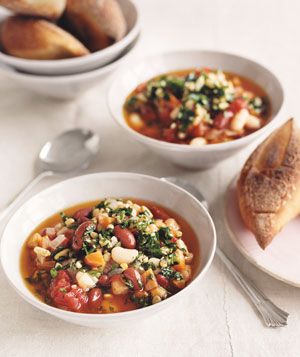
(0, 0, 67, 20)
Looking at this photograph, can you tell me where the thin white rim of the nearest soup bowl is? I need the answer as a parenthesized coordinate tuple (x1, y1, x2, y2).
(0, 172, 217, 321)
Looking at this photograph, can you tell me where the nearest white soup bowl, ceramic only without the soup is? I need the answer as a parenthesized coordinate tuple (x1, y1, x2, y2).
(1, 172, 216, 328)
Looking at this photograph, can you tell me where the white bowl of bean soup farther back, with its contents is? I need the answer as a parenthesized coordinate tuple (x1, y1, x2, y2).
(108, 50, 284, 169)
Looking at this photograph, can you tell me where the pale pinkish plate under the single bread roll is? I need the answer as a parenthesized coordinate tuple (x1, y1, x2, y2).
(225, 180, 300, 287)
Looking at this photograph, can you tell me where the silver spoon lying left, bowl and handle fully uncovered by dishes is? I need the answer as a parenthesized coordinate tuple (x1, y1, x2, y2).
(0, 128, 99, 221)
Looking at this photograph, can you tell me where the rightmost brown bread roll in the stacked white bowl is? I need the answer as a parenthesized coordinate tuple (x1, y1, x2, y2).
(65, 0, 126, 52)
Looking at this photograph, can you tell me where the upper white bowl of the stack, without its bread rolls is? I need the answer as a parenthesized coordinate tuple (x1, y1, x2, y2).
(0, 0, 140, 75)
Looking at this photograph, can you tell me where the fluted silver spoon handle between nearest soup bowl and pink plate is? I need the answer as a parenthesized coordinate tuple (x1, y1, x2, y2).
(216, 248, 289, 327)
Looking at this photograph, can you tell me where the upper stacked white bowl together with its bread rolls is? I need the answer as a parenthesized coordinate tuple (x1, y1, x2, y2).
(0, 0, 140, 76)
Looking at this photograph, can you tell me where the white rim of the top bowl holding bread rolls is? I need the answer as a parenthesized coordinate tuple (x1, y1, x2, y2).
(0, 0, 140, 69)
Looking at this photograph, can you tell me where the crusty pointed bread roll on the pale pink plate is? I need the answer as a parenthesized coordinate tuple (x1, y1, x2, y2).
(238, 119, 300, 249)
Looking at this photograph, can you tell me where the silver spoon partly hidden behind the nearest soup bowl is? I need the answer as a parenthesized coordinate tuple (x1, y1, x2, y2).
(162, 177, 289, 327)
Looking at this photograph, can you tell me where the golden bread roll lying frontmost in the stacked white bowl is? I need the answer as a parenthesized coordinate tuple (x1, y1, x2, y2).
(0, 16, 89, 60)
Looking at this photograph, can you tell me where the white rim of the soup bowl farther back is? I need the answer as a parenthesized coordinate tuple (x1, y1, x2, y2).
(108, 49, 285, 152)
